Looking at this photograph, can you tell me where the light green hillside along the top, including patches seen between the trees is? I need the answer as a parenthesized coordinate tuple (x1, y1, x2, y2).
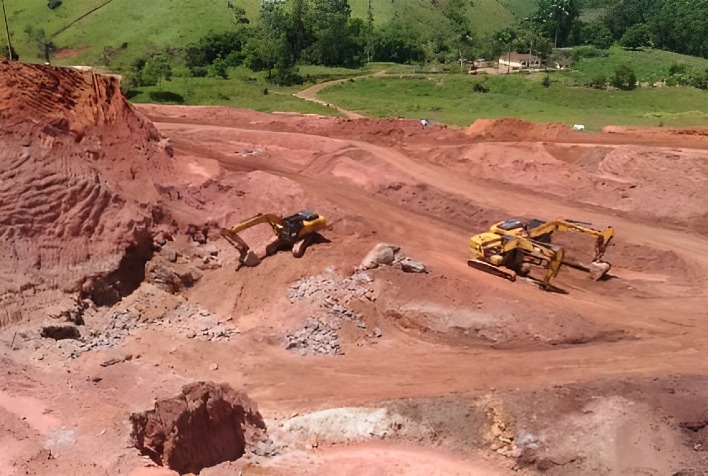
(5, 0, 524, 68)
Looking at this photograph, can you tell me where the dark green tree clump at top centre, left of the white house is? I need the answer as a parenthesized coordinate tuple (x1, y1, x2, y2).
(184, 0, 479, 85)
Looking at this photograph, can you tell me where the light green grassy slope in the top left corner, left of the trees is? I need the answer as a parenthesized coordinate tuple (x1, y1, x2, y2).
(6, 0, 231, 68)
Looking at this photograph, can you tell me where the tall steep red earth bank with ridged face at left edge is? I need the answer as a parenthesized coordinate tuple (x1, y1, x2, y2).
(0, 59, 172, 326)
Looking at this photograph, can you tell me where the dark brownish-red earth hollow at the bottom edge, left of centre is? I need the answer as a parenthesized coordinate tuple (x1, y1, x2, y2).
(130, 382, 266, 474)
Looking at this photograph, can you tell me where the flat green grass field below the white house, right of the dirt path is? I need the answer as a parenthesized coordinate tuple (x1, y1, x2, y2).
(319, 70, 708, 130)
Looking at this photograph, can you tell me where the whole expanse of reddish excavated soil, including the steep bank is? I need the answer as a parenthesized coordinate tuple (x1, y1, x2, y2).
(0, 60, 708, 475)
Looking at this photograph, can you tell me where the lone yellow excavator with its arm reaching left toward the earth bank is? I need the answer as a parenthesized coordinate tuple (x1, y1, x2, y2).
(221, 210, 327, 266)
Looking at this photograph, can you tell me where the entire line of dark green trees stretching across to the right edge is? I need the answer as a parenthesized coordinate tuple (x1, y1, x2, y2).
(120, 0, 708, 85)
